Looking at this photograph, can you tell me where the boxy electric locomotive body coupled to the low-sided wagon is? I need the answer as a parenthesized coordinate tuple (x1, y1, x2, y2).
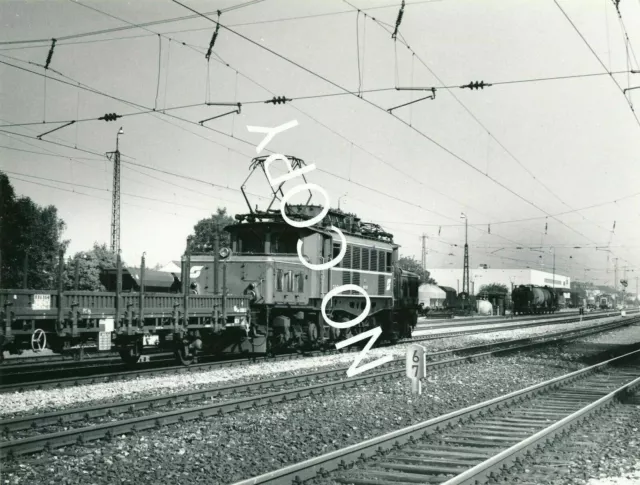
(189, 204, 419, 351)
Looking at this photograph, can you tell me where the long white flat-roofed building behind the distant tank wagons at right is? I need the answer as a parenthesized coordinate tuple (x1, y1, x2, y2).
(429, 265, 571, 295)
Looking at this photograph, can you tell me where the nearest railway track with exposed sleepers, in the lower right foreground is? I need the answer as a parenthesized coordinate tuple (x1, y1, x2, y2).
(229, 340, 640, 485)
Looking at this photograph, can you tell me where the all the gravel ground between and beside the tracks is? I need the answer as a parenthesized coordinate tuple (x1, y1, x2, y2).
(0, 315, 640, 485)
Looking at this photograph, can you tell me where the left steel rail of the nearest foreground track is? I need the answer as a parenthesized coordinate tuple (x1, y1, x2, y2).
(233, 340, 640, 485)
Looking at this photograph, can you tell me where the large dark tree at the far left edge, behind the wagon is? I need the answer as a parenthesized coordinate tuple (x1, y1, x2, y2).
(0, 172, 69, 289)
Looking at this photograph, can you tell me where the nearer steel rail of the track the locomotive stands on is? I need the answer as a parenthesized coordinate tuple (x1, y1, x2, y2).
(0, 313, 636, 394)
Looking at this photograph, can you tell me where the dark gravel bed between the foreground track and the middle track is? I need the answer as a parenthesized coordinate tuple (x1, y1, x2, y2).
(3, 320, 640, 484)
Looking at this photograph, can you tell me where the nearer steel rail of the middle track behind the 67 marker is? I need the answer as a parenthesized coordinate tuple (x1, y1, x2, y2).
(0, 317, 640, 457)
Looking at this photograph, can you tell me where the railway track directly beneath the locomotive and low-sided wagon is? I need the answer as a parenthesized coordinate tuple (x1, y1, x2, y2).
(0, 312, 632, 393)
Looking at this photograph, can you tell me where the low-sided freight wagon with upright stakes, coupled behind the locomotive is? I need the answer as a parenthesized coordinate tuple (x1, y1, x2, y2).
(0, 253, 255, 364)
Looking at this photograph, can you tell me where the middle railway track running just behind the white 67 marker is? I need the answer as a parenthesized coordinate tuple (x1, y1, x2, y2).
(0, 316, 640, 457)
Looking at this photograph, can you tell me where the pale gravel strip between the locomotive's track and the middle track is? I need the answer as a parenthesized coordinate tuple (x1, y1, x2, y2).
(0, 319, 632, 419)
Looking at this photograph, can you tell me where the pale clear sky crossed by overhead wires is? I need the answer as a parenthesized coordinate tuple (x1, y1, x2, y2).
(0, 0, 640, 288)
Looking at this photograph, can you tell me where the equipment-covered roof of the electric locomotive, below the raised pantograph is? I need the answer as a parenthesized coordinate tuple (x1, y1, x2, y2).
(225, 204, 395, 245)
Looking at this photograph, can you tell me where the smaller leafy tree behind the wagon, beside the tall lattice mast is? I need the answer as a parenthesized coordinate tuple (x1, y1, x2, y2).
(64, 242, 125, 291)
